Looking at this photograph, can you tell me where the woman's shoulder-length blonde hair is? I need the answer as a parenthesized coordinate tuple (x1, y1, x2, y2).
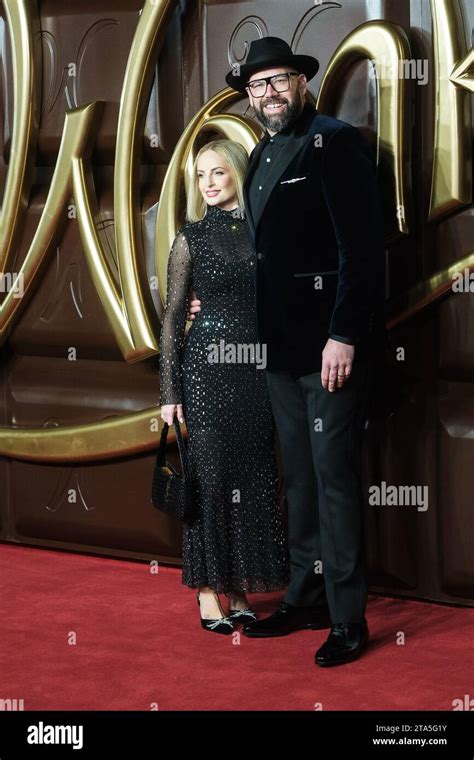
(186, 140, 249, 222)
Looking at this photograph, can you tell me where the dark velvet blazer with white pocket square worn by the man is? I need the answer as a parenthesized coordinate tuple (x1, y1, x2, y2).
(244, 103, 385, 375)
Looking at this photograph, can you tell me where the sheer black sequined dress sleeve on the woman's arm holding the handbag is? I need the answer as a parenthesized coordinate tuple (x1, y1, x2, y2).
(159, 232, 192, 405)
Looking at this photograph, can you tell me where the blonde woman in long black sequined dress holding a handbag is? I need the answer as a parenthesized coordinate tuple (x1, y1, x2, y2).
(160, 140, 289, 634)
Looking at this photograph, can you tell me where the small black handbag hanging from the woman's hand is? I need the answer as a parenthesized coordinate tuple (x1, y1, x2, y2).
(151, 417, 197, 522)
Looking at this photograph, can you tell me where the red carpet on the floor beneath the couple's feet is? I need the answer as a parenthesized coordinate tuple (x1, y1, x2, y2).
(0, 544, 474, 710)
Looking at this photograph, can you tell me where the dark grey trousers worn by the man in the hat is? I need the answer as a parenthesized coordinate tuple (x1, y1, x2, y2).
(266, 360, 373, 623)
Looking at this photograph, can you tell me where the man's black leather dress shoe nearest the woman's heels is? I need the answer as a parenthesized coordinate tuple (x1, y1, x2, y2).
(242, 602, 331, 638)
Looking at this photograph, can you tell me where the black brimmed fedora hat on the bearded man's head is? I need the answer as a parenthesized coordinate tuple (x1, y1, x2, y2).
(225, 37, 319, 92)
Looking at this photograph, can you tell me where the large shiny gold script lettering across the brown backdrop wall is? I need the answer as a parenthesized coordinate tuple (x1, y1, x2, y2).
(0, 0, 474, 461)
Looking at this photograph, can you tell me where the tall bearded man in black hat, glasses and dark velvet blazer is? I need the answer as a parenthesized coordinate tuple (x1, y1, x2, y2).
(185, 37, 384, 667)
